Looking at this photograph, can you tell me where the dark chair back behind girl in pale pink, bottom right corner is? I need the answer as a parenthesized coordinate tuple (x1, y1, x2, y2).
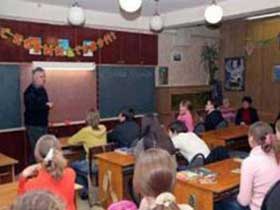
(261, 181, 280, 210)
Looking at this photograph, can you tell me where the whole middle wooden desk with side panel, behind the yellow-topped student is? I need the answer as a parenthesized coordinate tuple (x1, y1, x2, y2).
(96, 152, 135, 205)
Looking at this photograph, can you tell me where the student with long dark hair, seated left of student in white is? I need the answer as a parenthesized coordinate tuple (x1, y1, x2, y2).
(133, 114, 176, 157)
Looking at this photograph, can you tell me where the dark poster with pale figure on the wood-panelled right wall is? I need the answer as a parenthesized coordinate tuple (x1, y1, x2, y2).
(225, 57, 245, 91)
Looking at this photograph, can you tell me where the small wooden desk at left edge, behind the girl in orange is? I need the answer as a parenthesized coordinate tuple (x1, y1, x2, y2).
(0, 153, 18, 184)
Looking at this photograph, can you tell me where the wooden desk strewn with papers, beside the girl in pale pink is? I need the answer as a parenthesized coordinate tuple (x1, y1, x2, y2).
(174, 159, 240, 210)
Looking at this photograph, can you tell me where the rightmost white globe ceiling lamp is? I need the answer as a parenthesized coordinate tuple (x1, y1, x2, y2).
(204, 0, 223, 24)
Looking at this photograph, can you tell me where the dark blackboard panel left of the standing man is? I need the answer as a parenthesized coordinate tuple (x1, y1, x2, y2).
(0, 65, 21, 129)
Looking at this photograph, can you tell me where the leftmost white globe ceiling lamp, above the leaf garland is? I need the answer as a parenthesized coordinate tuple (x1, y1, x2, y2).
(68, 2, 86, 26)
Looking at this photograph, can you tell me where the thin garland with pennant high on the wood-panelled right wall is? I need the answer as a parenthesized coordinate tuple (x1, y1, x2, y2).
(244, 32, 280, 56)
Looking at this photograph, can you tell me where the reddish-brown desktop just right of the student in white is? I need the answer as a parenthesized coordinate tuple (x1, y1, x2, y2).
(201, 125, 249, 140)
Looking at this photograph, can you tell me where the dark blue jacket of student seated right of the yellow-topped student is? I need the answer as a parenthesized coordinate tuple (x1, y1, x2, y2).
(107, 120, 140, 148)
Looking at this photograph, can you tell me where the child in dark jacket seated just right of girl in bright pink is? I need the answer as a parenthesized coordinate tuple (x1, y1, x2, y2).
(204, 100, 225, 131)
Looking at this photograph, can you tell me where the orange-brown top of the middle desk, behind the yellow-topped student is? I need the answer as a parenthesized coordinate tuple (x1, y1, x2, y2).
(96, 152, 135, 167)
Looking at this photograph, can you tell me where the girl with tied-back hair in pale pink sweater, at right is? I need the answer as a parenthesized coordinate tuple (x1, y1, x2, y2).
(217, 122, 280, 210)
